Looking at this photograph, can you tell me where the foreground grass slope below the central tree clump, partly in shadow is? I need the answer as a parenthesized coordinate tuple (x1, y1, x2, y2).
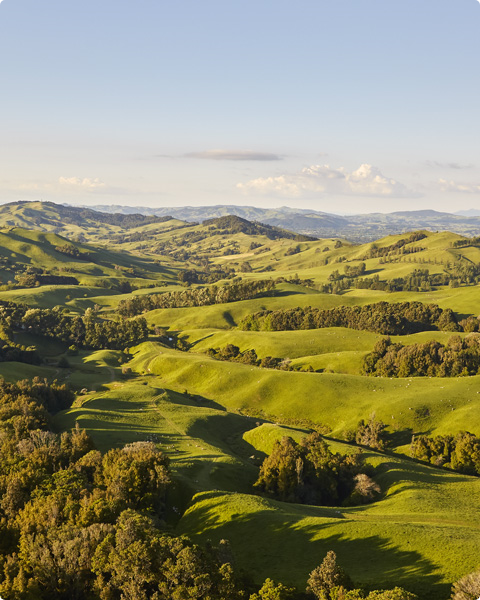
(178, 457, 480, 600)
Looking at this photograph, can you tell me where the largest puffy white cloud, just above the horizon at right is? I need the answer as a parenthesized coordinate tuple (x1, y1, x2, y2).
(237, 164, 420, 198)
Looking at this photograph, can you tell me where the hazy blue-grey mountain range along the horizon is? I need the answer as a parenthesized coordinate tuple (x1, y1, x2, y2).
(84, 204, 480, 242)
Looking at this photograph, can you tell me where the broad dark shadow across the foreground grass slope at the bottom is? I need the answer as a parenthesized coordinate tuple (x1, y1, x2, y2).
(180, 492, 450, 600)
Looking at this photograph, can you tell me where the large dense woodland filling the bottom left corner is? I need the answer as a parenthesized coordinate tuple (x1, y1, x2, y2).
(0, 380, 245, 600)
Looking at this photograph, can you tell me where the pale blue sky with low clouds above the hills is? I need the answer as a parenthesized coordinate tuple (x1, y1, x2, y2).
(0, 0, 480, 214)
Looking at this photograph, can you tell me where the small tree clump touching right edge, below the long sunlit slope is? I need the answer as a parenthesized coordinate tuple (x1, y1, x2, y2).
(410, 431, 480, 475)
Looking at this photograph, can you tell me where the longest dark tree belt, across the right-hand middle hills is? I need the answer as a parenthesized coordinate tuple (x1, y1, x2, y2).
(239, 302, 459, 335)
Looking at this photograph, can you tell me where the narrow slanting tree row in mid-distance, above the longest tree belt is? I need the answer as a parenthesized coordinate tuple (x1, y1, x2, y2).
(117, 279, 275, 317)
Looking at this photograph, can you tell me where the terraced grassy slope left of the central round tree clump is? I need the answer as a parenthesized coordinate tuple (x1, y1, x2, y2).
(56, 381, 262, 500)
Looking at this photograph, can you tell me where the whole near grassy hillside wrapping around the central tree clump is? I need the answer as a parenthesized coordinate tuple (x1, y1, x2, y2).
(56, 376, 480, 600)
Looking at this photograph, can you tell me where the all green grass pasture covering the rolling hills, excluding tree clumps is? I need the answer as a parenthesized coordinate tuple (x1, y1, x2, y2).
(0, 213, 480, 600)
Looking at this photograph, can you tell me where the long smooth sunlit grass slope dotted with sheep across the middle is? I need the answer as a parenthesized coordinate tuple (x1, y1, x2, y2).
(129, 342, 480, 435)
